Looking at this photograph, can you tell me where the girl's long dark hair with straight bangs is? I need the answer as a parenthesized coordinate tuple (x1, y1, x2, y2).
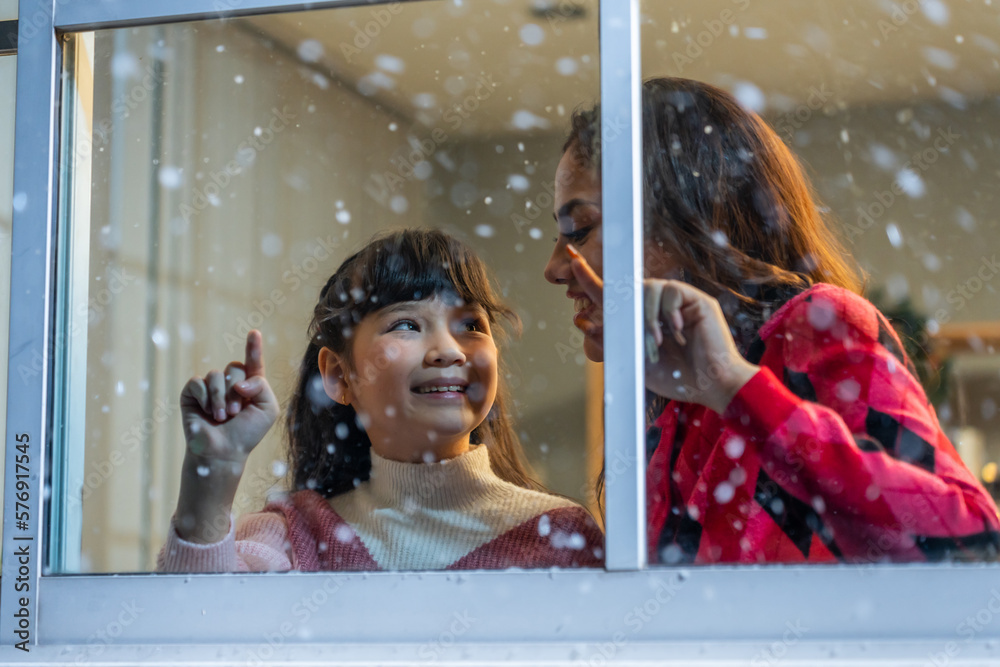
(285, 229, 541, 498)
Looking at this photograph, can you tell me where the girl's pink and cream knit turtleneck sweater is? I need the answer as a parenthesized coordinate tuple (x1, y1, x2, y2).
(157, 448, 604, 572)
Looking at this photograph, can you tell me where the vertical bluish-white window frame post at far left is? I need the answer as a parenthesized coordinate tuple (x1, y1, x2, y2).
(0, 0, 59, 646)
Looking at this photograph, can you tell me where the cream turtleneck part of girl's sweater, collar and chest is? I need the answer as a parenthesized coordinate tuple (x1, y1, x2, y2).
(330, 445, 576, 570)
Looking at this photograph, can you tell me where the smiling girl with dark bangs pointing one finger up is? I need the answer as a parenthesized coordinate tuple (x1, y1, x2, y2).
(159, 230, 603, 572)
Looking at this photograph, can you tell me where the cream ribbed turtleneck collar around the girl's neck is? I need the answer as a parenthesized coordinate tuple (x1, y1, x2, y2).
(369, 445, 504, 510)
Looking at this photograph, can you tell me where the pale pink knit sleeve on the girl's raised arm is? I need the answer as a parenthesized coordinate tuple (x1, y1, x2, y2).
(156, 512, 294, 572)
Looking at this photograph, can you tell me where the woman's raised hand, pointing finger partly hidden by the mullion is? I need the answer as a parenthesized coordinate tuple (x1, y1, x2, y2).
(570, 248, 759, 414)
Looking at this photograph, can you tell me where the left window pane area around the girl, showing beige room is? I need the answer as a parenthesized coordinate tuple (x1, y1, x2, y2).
(52, 3, 600, 572)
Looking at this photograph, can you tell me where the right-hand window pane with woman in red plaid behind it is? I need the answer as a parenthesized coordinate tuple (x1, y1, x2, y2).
(642, 0, 1000, 564)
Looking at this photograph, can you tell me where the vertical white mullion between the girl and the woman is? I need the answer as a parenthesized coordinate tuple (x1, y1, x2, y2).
(600, 0, 646, 570)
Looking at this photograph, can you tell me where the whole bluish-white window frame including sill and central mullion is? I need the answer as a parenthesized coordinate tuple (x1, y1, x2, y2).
(0, 0, 1000, 665)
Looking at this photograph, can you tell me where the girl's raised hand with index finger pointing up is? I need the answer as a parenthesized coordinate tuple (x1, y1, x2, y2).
(181, 330, 278, 463)
